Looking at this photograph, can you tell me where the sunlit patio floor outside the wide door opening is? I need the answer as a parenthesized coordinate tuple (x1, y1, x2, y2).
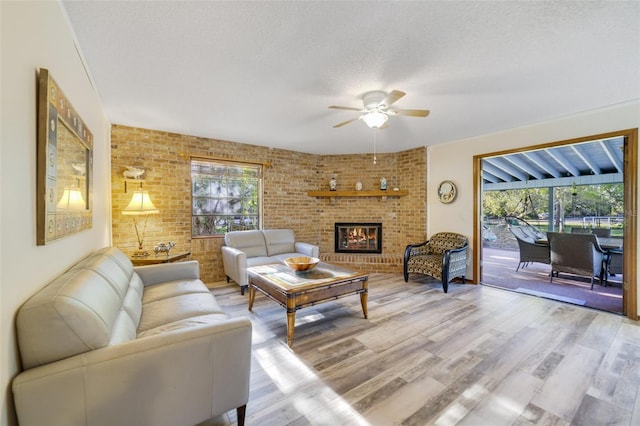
(481, 247, 623, 314)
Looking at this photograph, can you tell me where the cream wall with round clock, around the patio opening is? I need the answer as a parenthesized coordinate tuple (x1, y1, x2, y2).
(427, 100, 640, 304)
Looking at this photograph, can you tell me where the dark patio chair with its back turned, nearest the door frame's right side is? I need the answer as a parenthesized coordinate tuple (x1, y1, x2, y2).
(547, 232, 606, 290)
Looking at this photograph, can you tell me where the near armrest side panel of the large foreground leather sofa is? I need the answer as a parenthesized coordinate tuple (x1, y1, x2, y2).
(13, 317, 251, 425)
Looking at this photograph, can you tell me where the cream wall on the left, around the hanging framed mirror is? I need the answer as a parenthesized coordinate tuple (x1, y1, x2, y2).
(0, 1, 111, 425)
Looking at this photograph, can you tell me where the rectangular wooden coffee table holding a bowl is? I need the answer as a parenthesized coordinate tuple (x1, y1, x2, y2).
(247, 262, 369, 347)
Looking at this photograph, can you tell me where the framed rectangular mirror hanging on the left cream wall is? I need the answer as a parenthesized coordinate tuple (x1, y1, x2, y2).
(36, 68, 93, 246)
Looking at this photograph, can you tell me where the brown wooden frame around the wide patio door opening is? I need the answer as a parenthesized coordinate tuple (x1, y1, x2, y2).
(473, 128, 640, 321)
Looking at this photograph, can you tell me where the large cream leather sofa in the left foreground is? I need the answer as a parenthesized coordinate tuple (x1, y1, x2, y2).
(12, 248, 251, 426)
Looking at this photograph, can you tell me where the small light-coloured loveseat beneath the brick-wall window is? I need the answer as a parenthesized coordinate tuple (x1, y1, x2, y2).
(222, 229, 320, 294)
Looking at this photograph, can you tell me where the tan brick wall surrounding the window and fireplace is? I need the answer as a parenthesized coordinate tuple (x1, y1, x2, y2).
(111, 125, 426, 283)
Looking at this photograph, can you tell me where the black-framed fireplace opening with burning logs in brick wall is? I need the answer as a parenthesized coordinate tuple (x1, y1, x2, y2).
(334, 223, 382, 253)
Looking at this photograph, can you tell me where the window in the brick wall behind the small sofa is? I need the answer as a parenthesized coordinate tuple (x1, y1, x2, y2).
(191, 159, 262, 237)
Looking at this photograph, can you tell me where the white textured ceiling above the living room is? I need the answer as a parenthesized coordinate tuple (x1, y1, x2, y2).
(61, 0, 640, 154)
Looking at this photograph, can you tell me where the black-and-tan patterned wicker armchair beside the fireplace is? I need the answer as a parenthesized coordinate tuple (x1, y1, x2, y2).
(404, 232, 469, 293)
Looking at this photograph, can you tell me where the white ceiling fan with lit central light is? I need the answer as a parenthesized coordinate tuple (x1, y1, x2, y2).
(329, 90, 429, 129)
